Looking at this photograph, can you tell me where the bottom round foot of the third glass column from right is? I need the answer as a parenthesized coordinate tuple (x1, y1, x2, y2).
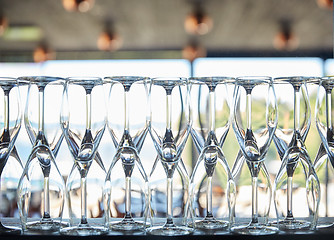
(231, 223, 278, 235)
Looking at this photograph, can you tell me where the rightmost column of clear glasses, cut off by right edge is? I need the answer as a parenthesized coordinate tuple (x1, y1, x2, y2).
(314, 77, 334, 228)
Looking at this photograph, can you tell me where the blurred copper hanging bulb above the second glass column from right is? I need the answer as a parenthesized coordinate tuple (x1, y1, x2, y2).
(273, 20, 299, 51)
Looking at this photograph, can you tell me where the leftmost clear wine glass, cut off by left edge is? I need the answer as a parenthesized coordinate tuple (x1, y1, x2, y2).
(0, 77, 23, 234)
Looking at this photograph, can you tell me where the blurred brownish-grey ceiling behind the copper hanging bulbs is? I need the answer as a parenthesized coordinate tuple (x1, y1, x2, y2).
(0, 0, 333, 60)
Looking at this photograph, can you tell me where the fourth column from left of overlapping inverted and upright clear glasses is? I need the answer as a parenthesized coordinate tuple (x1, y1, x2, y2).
(104, 76, 150, 231)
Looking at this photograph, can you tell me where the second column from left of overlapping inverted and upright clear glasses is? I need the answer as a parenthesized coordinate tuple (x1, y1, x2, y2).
(18, 76, 65, 231)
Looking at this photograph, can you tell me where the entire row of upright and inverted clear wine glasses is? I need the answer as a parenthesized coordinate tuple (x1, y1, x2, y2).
(0, 76, 334, 235)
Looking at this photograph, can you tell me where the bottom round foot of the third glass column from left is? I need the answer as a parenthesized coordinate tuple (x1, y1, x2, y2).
(60, 224, 108, 236)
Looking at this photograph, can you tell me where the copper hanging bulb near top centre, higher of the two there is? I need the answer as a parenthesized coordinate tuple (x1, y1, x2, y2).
(184, 5, 213, 35)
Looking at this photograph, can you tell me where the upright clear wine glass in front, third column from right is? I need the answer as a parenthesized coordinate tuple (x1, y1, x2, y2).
(231, 77, 278, 235)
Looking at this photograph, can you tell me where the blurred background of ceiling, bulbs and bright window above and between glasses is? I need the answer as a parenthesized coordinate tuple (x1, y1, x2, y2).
(0, 0, 334, 220)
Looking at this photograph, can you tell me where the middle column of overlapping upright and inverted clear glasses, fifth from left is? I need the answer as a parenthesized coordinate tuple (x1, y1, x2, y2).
(146, 78, 193, 236)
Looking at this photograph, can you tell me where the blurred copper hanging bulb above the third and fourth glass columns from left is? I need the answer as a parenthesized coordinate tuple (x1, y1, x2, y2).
(97, 31, 123, 51)
